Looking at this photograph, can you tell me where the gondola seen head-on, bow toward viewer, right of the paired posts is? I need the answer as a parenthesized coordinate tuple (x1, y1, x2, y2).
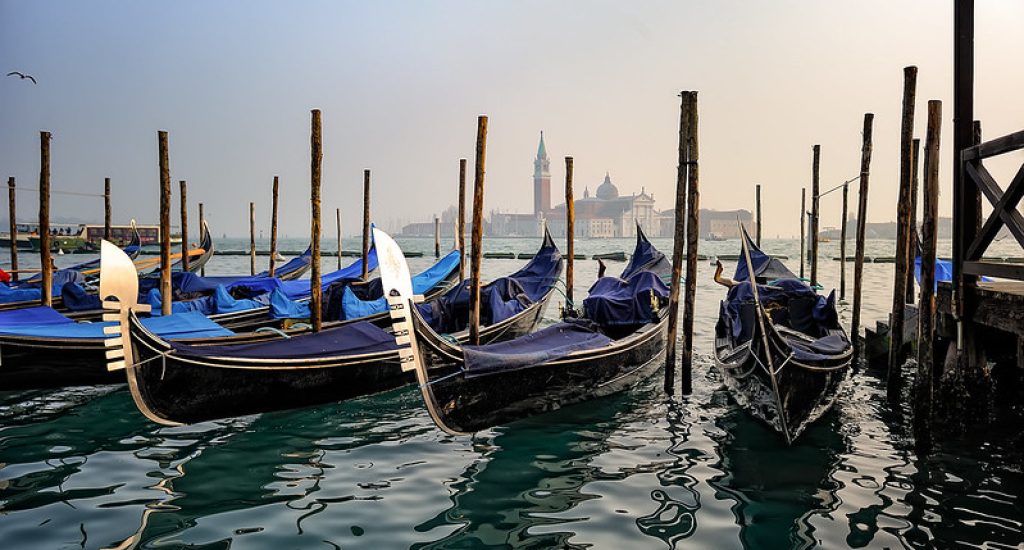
(715, 225, 853, 445)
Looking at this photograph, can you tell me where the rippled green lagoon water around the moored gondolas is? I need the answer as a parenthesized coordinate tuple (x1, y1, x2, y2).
(0, 240, 1024, 549)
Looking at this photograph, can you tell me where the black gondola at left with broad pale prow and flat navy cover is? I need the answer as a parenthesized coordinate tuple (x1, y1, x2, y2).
(100, 228, 562, 425)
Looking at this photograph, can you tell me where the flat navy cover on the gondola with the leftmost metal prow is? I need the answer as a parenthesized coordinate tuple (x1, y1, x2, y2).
(171, 321, 397, 359)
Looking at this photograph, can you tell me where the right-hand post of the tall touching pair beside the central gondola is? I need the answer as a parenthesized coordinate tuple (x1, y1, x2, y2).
(672, 91, 700, 395)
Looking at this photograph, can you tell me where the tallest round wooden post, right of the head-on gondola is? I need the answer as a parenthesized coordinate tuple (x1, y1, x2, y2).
(887, 66, 918, 391)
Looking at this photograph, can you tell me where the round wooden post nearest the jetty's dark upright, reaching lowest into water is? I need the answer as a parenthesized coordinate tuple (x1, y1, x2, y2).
(913, 99, 942, 452)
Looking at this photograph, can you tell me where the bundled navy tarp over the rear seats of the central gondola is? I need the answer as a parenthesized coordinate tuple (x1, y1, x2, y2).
(583, 271, 669, 326)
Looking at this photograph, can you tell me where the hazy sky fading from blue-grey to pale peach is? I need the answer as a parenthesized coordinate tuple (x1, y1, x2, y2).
(0, 0, 1024, 237)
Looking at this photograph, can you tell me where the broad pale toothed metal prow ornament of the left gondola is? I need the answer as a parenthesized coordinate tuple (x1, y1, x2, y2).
(99, 241, 151, 371)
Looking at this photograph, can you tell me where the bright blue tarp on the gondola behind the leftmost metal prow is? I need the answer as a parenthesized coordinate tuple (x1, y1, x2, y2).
(0, 307, 233, 340)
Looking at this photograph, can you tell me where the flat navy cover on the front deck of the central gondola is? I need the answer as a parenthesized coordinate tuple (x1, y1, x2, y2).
(462, 321, 611, 378)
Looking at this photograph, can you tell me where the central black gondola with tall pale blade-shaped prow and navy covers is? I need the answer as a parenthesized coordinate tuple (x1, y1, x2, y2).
(377, 225, 671, 434)
